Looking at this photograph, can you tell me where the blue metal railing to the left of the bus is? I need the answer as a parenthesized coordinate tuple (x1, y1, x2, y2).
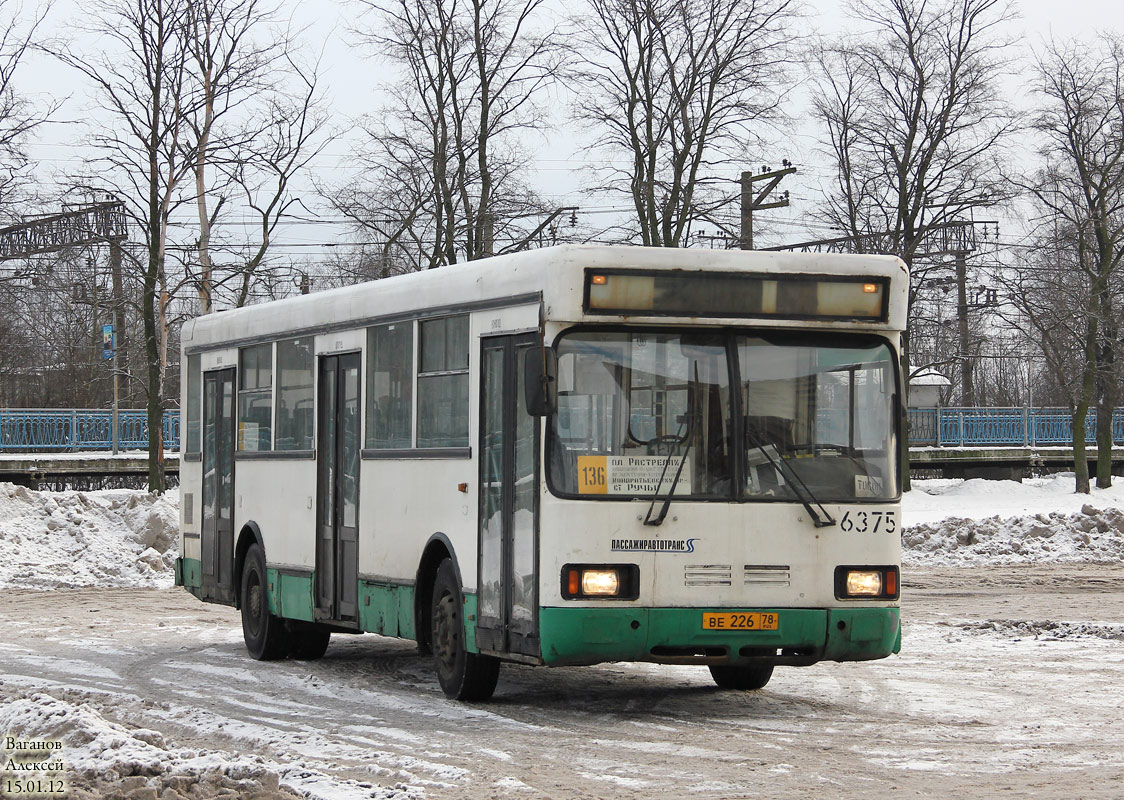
(0, 408, 180, 453)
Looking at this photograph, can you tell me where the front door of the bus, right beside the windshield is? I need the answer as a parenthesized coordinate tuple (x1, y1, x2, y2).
(477, 335, 540, 656)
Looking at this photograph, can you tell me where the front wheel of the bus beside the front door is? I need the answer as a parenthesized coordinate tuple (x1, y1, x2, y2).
(429, 558, 499, 700)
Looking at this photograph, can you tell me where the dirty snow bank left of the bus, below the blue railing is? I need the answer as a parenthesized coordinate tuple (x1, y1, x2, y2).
(0, 483, 179, 589)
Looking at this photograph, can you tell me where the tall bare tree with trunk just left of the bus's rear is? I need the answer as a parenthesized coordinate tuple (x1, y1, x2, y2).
(54, 0, 198, 491)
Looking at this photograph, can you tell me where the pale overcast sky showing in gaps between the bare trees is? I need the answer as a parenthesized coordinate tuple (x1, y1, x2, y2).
(8, 0, 1124, 255)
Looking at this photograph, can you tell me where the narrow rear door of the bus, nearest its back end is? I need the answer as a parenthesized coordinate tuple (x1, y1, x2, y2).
(199, 370, 234, 602)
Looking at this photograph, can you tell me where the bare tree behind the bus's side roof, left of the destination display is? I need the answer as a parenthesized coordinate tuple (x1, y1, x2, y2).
(332, 0, 559, 269)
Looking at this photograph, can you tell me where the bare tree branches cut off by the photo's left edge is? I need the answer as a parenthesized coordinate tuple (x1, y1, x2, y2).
(0, 0, 55, 219)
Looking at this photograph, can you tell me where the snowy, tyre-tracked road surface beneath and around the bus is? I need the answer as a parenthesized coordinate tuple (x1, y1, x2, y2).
(0, 565, 1124, 800)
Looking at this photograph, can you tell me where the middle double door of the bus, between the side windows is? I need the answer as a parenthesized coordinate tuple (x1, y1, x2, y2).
(316, 353, 360, 622)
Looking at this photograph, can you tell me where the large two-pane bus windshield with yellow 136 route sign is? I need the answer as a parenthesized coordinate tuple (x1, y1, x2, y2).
(547, 330, 898, 502)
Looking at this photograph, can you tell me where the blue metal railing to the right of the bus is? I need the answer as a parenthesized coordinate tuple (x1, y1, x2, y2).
(909, 408, 1124, 447)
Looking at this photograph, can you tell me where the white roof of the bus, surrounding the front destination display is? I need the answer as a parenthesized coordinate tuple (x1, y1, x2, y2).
(181, 245, 908, 351)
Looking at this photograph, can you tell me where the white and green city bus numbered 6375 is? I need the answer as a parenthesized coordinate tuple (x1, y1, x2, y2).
(175, 245, 908, 701)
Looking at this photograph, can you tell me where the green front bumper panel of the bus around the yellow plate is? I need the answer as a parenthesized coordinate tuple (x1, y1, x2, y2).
(538, 608, 901, 665)
